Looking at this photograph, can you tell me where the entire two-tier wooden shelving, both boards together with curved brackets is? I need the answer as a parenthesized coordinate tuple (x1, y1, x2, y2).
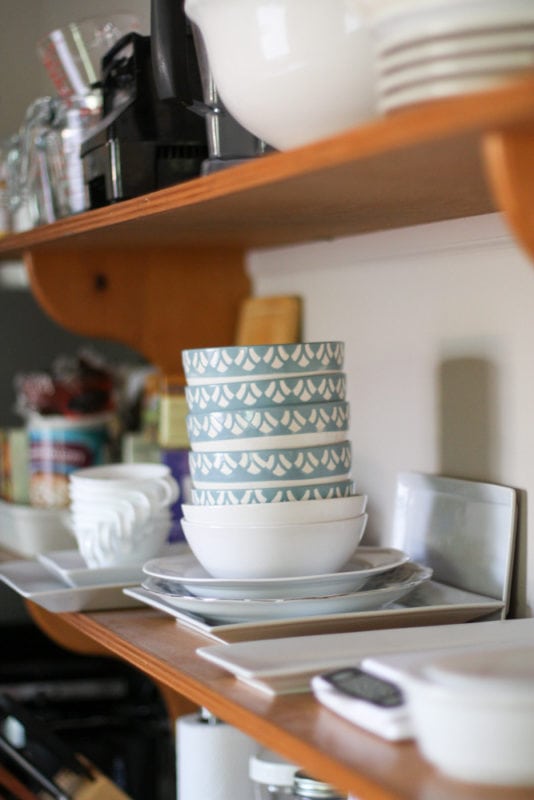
(8, 78, 534, 800)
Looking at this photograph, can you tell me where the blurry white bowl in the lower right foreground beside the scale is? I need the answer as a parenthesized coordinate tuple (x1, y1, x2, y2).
(403, 646, 534, 796)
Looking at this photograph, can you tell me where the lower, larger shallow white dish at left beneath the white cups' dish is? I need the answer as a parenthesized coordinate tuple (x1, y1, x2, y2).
(0, 561, 139, 613)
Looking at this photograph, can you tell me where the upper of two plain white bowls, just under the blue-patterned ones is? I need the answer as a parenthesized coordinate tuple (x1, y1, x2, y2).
(182, 494, 367, 526)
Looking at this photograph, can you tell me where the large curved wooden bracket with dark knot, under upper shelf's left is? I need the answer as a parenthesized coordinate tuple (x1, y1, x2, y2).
(25, 244, 250, 374)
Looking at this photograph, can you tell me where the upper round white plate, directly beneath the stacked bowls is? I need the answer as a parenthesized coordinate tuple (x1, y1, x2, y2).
(143, 547, 408, 600)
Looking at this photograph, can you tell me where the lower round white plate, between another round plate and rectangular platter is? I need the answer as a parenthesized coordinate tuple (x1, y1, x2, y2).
(142, 562, 432, 622)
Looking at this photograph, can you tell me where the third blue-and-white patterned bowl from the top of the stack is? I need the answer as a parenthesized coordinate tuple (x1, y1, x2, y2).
(186, 402, 349, 449)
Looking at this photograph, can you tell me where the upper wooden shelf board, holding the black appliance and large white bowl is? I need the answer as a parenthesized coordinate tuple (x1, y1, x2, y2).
(0, 73, 534, 257)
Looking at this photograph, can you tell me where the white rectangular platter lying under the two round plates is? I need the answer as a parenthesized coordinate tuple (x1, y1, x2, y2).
(124, 581, 502, 643)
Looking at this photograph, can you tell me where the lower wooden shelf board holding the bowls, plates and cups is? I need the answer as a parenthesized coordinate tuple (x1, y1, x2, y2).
(29, 603, 534, 800)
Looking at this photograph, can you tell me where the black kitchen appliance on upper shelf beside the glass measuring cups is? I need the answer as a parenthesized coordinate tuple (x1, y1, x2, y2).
(80, 0, 208, 208)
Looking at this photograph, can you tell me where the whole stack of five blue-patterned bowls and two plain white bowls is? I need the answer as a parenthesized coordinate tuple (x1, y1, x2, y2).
(182, 342, 367, 578)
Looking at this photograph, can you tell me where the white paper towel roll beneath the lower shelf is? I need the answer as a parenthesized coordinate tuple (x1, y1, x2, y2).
(176, 714, 259, 800)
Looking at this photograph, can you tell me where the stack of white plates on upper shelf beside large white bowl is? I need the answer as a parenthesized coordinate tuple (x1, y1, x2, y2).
(373, 0, 534, 113)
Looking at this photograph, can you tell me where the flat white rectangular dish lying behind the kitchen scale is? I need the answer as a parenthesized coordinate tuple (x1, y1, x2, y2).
(197, 620, 534, 695)
